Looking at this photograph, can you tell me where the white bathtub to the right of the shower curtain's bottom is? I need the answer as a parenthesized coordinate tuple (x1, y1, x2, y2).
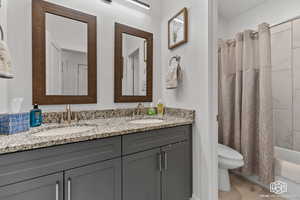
(275, 147, 300, 200)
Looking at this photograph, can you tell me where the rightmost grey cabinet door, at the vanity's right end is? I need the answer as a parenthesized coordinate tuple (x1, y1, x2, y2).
(162, 142, 192, 200)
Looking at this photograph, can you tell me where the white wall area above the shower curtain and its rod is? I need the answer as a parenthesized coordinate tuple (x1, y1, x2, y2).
(228, 0, 300, 37)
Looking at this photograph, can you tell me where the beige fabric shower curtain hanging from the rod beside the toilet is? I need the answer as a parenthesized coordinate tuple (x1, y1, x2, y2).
(219, 24, 274, 184)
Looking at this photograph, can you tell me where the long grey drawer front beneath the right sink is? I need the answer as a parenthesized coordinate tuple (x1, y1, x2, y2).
(123, 126, 191, 155)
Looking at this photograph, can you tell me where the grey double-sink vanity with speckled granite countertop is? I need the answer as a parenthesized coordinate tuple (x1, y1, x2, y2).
(0, 109, 193, 200)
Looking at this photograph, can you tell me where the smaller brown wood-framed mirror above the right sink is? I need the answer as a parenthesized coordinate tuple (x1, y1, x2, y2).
(115, 23, 153, 103)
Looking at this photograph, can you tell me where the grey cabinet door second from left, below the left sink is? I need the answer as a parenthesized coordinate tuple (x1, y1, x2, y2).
(65, 158, 121, 200)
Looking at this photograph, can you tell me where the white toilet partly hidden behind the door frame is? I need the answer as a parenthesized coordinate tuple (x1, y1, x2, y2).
(218, 144, 244, 192)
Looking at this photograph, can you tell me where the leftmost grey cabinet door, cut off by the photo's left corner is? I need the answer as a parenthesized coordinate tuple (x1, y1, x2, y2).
(0, 174, 63, 200)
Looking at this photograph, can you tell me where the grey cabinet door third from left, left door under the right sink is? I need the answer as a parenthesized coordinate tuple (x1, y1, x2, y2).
(123, 149, 161, 200)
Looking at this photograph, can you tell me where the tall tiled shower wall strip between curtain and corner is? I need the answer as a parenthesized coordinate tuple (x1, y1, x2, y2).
(271, 23, 293, 149)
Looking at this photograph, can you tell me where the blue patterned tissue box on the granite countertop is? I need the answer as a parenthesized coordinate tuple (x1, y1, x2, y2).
(0, 113, 30, 135)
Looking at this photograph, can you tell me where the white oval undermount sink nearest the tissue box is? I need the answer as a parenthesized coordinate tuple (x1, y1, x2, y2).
(34, 125, 96, 137)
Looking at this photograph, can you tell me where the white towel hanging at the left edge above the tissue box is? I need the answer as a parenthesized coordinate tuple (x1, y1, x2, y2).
(0, 40, 12, 76)
